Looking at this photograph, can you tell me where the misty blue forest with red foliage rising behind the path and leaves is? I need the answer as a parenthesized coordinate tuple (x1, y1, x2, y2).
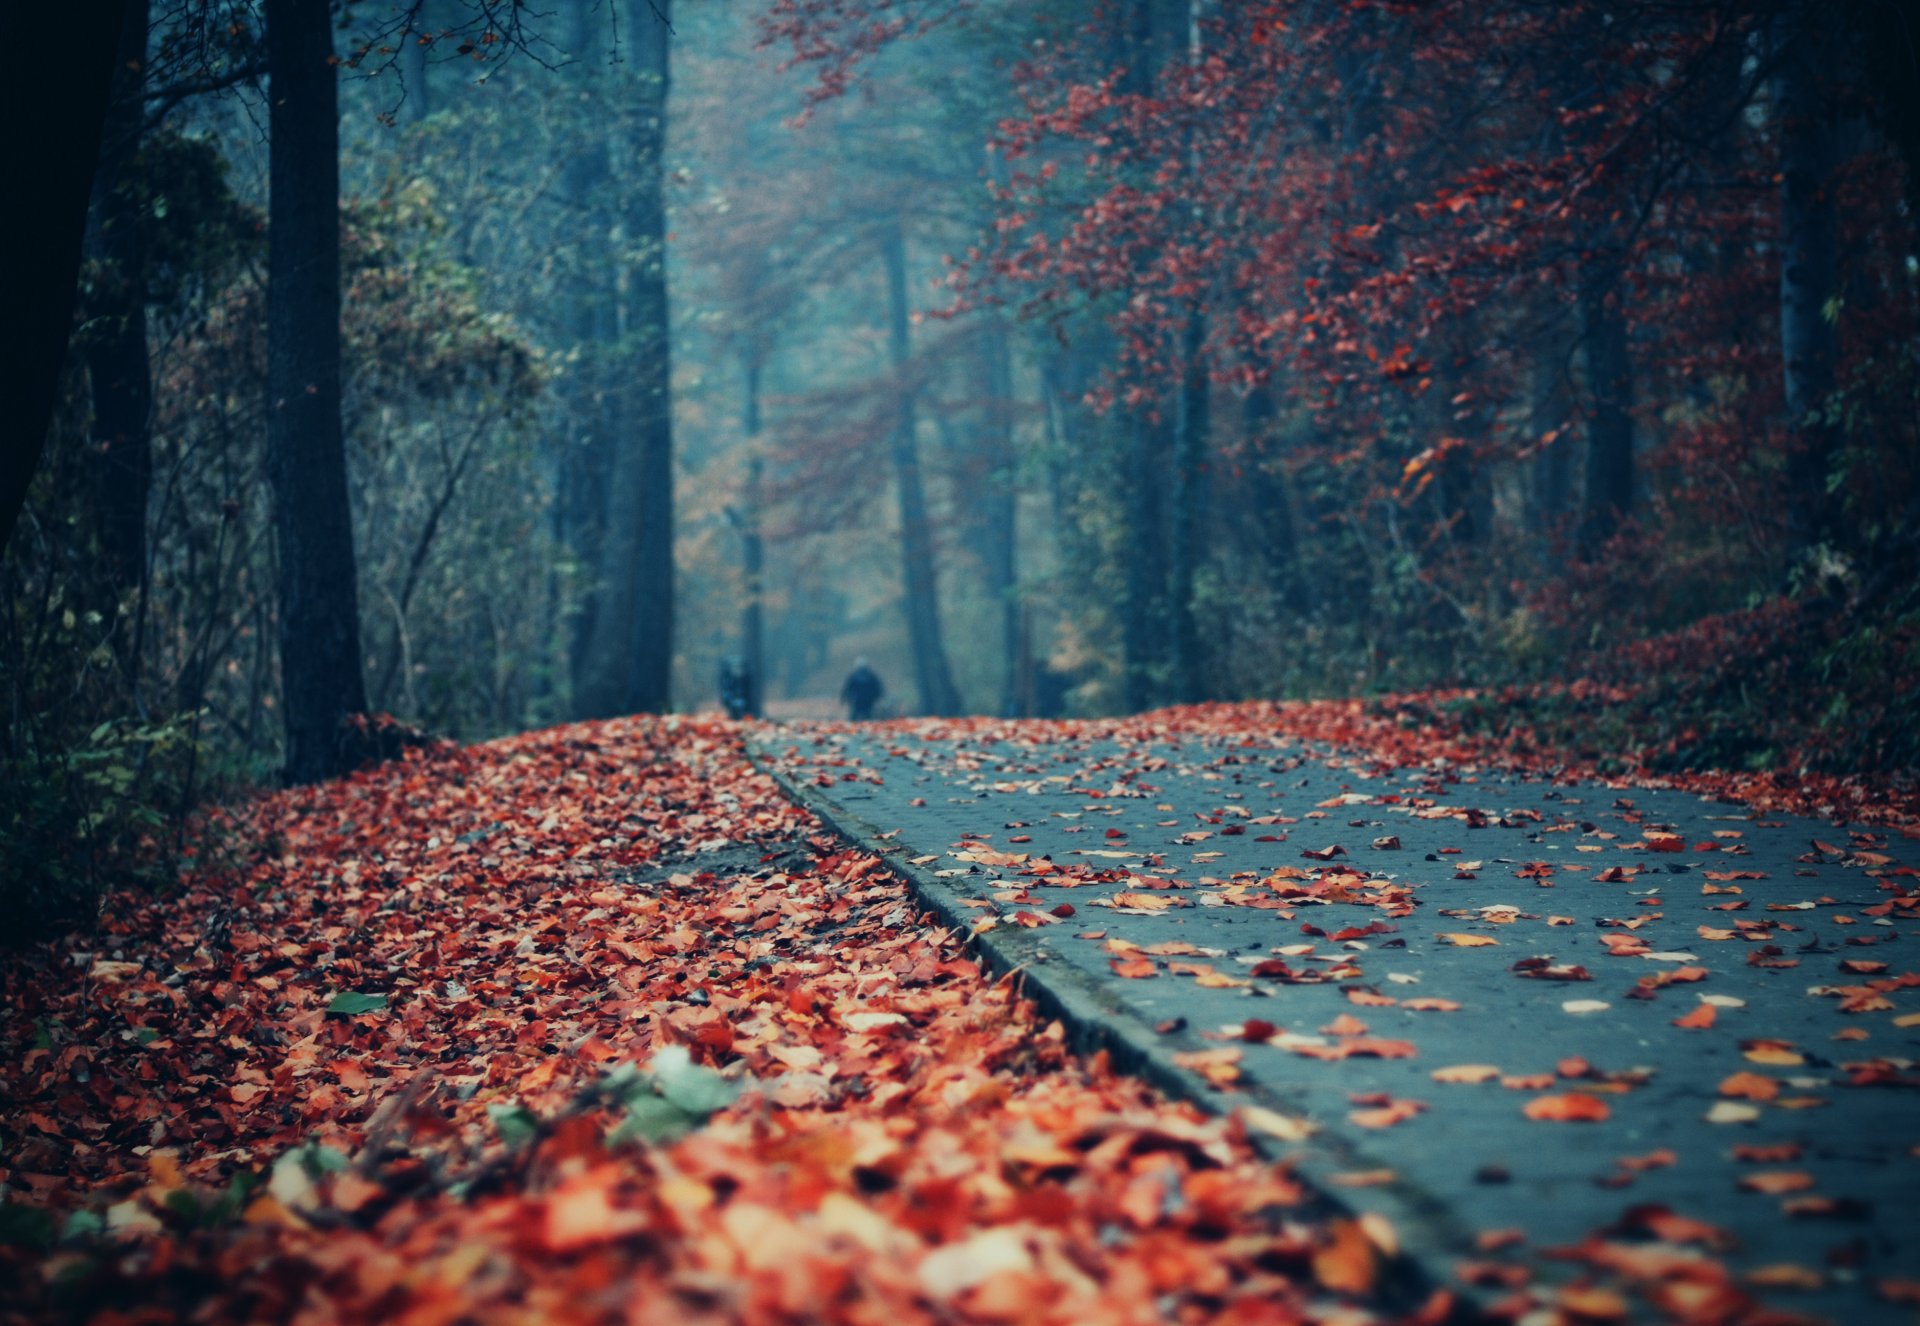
(0, 0, 1920, 932)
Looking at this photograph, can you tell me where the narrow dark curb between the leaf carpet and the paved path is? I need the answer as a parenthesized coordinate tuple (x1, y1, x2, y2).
(745, 731, 1484, 1322)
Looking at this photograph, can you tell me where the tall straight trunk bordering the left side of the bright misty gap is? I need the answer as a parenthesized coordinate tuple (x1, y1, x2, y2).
(622, 0, 674, 714)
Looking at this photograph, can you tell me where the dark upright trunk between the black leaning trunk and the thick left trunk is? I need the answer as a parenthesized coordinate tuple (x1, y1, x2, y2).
(86, 0, 154, 621)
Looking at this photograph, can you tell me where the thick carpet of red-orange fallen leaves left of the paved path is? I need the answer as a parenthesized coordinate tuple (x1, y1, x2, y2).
(0, 720, 1413, 1322)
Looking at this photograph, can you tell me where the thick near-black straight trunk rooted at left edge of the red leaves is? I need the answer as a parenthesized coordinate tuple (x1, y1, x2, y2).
(267, 0, 367, 783)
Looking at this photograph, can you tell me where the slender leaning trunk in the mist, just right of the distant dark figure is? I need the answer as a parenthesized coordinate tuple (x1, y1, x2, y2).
(881, 221, 960, 714)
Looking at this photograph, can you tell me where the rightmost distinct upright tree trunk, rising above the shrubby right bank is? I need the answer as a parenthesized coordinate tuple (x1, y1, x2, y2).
(1774, 0, 1839, 558)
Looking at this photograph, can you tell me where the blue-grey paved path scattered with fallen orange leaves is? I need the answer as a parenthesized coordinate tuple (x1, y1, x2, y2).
(760, 723, 1920, 1324)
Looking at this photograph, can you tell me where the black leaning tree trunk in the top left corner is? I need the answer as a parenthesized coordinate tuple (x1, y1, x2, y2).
(0, 0, 127, 551)
